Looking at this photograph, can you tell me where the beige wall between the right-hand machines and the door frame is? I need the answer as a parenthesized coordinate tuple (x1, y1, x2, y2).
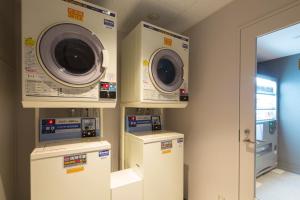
(167, 0, 294, 200)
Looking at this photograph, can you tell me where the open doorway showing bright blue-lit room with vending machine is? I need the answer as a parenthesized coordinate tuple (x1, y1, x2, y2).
(255, 24, 300, 200)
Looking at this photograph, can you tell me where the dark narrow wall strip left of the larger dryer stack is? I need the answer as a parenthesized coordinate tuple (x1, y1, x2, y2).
(0, 0, 16, 200)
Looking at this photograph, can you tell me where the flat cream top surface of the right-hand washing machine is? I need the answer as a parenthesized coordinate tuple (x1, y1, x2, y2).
(129, 130, 184, 144)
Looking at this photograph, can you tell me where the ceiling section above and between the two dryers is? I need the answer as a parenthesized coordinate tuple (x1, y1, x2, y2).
(86, 0, 233, 33)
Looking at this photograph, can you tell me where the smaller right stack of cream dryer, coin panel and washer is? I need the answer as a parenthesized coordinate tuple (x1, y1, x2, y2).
(121, 22, 189, 200)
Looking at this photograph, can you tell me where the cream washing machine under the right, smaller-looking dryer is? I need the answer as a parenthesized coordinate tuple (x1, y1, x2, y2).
(125, 131, 184, 200)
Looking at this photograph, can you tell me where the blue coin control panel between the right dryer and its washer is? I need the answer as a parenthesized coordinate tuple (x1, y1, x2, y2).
(126, 115, 162, 133)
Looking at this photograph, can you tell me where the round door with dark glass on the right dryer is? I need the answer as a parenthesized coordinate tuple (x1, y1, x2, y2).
(149, 49, 184, 93)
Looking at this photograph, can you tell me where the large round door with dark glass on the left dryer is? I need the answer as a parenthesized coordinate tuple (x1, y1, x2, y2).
(38, 23, 105, 87)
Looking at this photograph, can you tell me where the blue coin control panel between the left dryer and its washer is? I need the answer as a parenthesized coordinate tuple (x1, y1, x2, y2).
(40, 117, 100, 142)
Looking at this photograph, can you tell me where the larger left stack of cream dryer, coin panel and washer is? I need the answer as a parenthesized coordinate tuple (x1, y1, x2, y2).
(21, 0, 117, 200)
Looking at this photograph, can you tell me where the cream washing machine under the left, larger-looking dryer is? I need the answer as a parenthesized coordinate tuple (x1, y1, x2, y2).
(30, 141, 111, 200)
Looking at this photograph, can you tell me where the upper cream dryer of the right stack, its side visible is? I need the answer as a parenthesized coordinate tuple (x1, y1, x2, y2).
(121, 22, 189, 107)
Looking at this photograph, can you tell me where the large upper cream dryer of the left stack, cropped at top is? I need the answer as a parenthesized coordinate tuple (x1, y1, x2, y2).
(22, 0, 117, 107)
